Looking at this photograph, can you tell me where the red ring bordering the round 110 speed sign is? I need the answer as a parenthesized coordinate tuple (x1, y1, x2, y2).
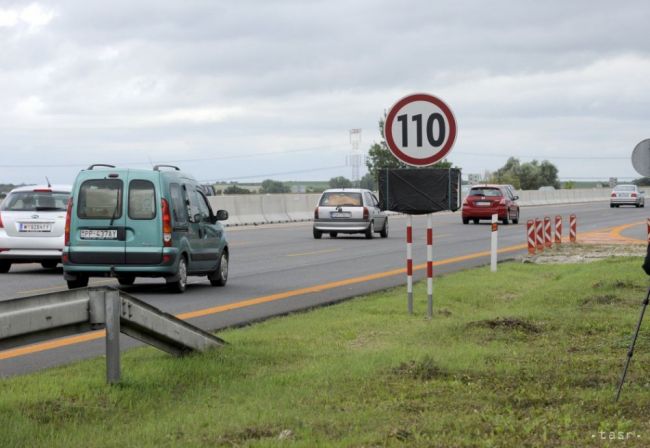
(384, 93, 456, 166)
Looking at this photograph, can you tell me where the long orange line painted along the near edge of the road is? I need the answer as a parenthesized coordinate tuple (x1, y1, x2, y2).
(0, 244, 528, 360)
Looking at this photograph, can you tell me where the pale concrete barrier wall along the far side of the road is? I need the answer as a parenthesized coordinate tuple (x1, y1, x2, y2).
(209, 188, 611, 226)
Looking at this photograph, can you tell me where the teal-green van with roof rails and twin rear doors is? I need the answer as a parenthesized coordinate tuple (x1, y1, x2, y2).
(62, 164, 229, 293)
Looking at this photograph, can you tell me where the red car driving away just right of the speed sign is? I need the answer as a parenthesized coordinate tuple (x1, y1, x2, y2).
(462, 185, 519, 224)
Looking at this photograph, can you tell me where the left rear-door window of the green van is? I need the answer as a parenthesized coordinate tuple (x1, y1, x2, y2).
(77, 179, 122, 219)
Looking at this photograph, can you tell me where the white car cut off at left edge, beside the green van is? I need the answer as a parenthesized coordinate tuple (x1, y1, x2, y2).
(0, 185, 72, 273)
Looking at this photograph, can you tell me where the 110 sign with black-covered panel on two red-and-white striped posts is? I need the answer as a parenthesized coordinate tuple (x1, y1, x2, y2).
(378, 93, 461, 318)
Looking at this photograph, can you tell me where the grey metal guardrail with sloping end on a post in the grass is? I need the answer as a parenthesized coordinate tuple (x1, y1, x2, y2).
(0, 287, 225, 384)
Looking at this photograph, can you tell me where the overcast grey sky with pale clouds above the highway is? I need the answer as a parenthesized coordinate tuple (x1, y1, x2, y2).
(0, 0, 650, 183)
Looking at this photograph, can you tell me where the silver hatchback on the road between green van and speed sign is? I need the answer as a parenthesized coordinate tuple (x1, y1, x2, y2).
(314, 188, 388, 239)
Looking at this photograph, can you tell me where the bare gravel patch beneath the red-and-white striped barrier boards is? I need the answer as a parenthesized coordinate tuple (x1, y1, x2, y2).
(522, 244, 646, 264)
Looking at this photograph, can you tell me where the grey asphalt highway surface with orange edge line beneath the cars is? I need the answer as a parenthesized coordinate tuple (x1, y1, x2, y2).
(0, 202, 647, 377)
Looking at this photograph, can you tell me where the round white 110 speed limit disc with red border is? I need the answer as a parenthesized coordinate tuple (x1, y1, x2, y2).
(384, 93, 456, 166)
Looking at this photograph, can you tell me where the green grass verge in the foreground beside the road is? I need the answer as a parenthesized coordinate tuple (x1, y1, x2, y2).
(0, 258, 650, 447)
